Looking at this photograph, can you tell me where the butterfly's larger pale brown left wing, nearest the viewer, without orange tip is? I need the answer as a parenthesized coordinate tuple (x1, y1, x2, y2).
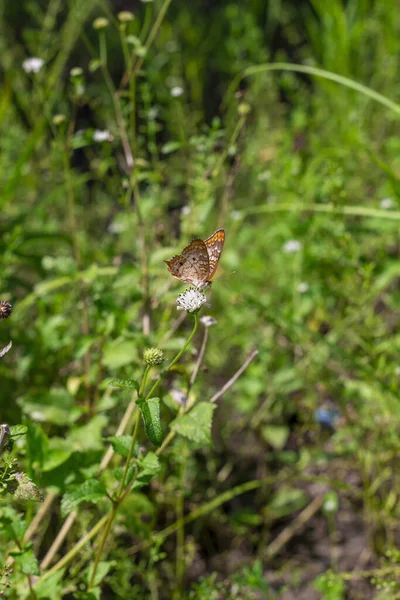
(165, 239, 209, 287)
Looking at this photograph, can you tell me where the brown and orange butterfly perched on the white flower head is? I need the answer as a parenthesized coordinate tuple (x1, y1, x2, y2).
(164, 229, 225, 290)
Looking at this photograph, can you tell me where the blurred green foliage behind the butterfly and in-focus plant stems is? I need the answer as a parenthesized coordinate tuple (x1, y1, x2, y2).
(0, 0, 400, 600)
